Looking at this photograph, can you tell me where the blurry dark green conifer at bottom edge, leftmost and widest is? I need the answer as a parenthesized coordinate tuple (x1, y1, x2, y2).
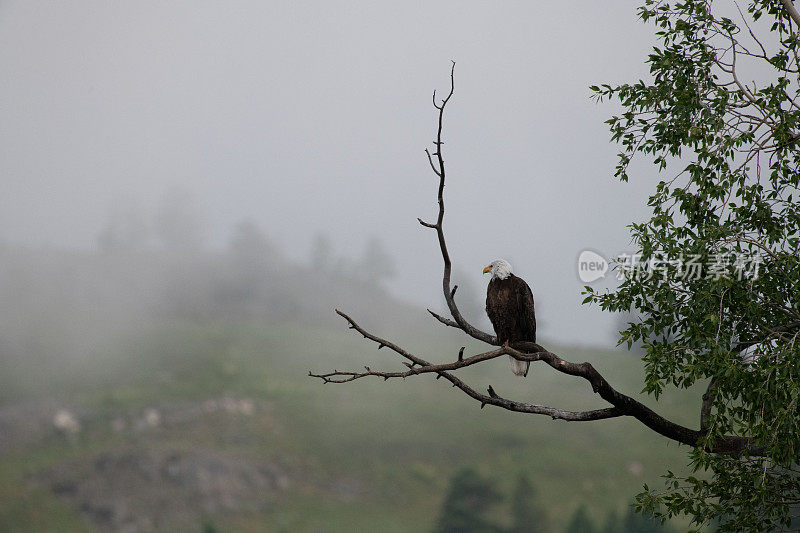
(436, 467, 502, 533)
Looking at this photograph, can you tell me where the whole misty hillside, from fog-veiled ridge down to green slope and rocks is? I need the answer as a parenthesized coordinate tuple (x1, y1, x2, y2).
(0, 234, 693, 531)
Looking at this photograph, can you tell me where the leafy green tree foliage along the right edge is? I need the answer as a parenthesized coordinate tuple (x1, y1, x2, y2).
(587, 0, 800, 531)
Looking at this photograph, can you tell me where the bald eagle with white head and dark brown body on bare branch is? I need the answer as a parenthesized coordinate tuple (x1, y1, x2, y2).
(483, 259, 536, 376)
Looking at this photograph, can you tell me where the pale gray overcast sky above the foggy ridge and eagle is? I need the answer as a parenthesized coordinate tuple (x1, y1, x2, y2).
(0, 0, 655, 343)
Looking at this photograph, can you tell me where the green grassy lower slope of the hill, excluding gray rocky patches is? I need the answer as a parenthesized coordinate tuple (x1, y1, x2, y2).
(0, 323, 699, 531)
